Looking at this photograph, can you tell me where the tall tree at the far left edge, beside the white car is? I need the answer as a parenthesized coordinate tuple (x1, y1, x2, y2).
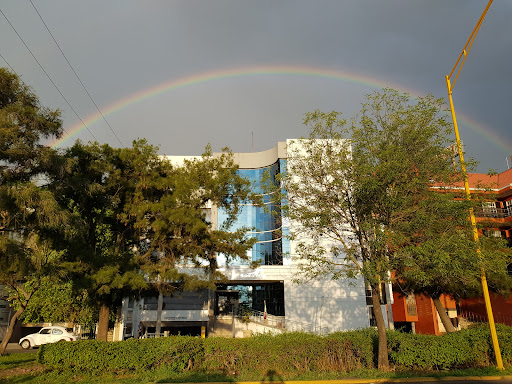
(0, 68, 67, 354)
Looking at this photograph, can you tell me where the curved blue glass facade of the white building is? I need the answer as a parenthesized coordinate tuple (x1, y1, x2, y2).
(218, 160, 290, 265)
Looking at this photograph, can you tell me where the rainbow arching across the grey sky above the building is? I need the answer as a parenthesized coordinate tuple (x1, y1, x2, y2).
(50, 66, 512, 153)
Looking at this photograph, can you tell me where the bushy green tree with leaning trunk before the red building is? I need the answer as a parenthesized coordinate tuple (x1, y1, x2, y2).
(393, 189, 512, 332)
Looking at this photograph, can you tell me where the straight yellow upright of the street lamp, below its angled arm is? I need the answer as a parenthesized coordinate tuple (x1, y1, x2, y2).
(446, 76, 505, 369)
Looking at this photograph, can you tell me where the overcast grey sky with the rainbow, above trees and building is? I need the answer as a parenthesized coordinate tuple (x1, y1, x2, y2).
(0, 0, 512, 172)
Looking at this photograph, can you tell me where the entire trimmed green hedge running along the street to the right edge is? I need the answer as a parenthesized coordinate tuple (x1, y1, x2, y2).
(38, 324, 512, 375)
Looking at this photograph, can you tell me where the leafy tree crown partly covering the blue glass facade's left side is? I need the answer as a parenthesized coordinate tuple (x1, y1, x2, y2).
(125, 146, 256, 310)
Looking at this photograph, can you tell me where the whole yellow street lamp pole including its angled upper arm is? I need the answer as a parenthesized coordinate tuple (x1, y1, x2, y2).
(446, 0, 504, 369)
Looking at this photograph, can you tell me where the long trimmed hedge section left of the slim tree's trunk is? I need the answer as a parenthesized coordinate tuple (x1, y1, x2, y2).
(38, 331, 376, 376)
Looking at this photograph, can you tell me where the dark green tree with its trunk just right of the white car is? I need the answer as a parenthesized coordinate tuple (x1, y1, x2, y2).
(50, 142, 152, 341)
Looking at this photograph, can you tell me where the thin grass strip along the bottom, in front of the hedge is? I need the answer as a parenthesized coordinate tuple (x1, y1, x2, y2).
(0, 353, 512, 384)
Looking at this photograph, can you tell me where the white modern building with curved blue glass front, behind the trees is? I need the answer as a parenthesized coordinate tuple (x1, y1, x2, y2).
(114, 141, 392, 340)
